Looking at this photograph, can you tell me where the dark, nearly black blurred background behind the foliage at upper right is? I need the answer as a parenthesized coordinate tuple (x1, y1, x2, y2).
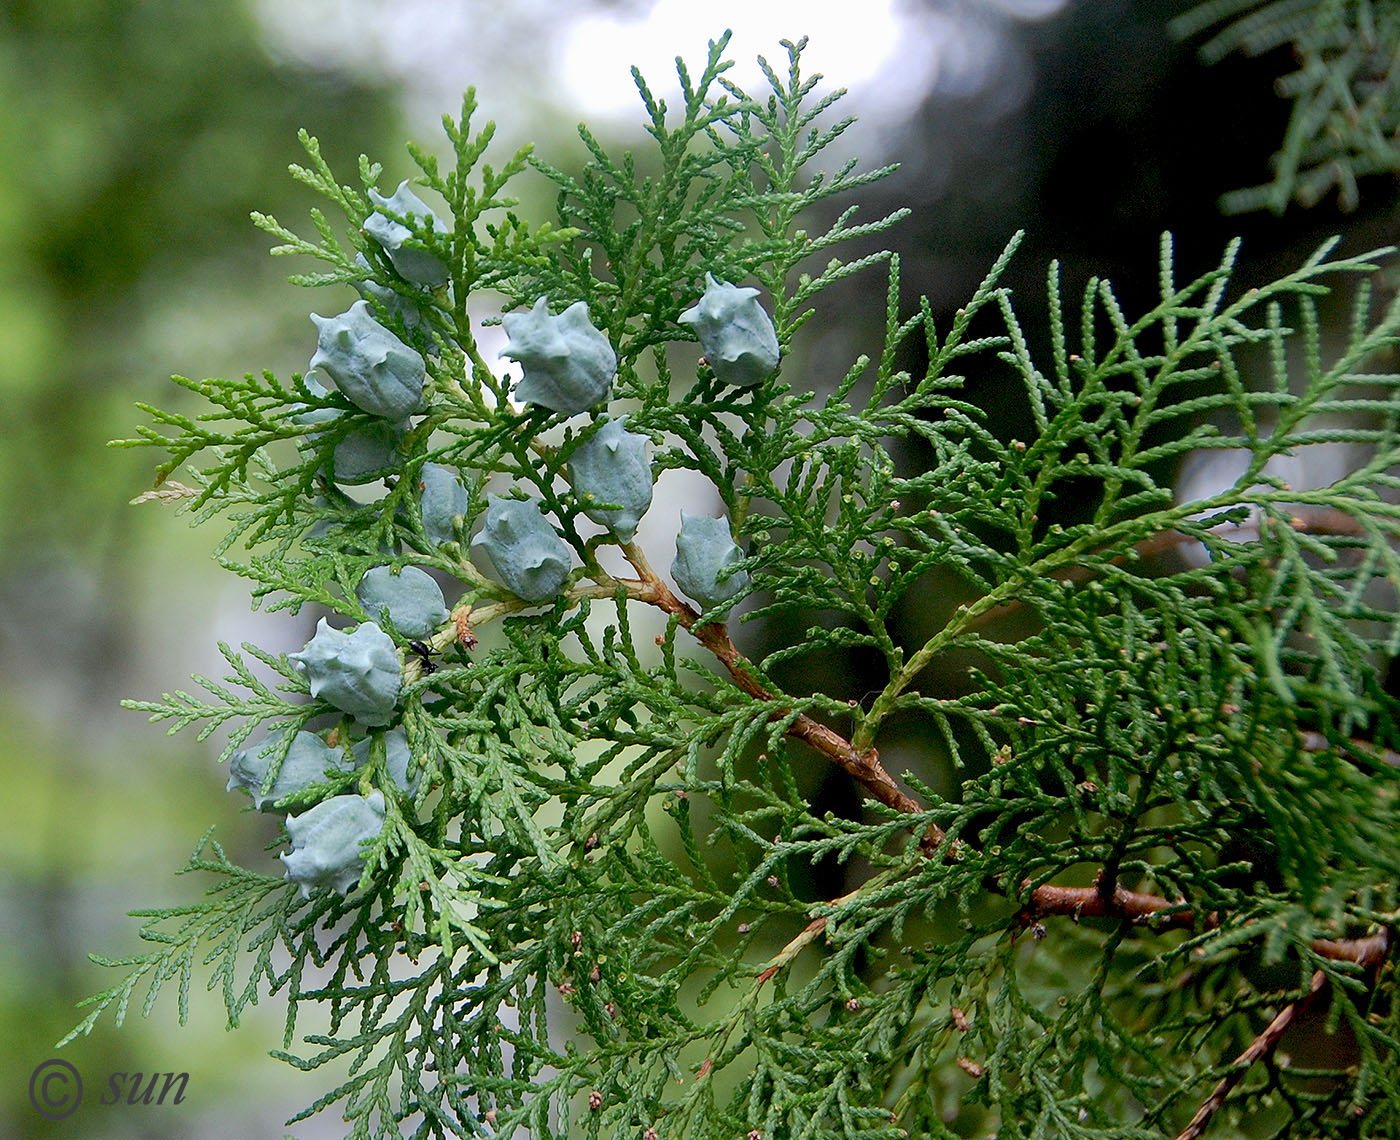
(741, 3, 1400, 913)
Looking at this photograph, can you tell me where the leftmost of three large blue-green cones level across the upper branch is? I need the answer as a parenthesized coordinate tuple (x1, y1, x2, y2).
(309, 301, 426, 422)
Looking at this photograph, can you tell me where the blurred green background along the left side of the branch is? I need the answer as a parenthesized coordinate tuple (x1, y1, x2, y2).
(0, 0, 402, 1137)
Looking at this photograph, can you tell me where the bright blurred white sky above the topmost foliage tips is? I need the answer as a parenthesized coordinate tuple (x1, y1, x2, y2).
(256, 0, 1067, 146)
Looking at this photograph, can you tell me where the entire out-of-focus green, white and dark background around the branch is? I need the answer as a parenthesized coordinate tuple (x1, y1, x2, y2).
(0, 0, 1397, 1139)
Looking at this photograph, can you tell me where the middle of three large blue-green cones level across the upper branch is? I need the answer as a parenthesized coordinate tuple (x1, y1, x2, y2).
(500, 297, 617, 415)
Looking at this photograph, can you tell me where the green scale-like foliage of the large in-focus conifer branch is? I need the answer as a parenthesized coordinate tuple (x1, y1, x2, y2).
(74, 31, 1400, 1140)
